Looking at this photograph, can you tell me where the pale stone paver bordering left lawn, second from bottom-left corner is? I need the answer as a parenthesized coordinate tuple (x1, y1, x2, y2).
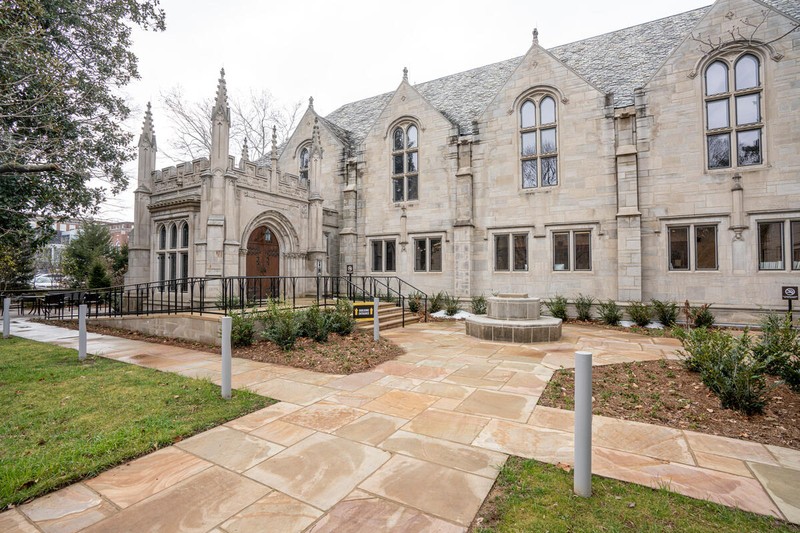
(19, 483, 116, 533)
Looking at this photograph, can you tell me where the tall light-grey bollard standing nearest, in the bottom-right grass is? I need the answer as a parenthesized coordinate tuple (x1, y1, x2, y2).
(573, 352, 592, 498)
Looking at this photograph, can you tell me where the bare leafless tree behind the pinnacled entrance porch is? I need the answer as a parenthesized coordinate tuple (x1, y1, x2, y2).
(161, 86, 300, 161)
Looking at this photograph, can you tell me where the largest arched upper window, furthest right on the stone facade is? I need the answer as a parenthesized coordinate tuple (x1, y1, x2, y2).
(704, 54, 764, 169)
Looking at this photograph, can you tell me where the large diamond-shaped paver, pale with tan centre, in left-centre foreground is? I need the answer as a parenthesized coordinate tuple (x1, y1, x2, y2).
(245, 433, 390, 510)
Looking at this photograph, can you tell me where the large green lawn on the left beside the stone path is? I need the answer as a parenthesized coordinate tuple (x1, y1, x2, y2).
(0, 338, 274, 511)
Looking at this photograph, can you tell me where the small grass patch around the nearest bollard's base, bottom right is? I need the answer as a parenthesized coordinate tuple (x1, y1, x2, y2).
(471, 457, 800, 533)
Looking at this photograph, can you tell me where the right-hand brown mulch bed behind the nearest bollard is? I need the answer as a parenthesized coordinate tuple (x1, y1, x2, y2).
(539, 361, 800, 450)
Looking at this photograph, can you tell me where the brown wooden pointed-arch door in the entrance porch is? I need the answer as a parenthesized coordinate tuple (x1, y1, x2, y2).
(246, 225, 281, 301)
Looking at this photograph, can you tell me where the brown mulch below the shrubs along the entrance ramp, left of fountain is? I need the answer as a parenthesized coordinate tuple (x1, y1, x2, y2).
(35, 319, 404, 374)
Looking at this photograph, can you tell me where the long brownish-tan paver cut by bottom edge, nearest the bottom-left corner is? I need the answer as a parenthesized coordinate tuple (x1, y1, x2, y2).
(86, 466, 270, 533)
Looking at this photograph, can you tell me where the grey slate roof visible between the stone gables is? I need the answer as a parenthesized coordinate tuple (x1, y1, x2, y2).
(326, 5, 720, 144)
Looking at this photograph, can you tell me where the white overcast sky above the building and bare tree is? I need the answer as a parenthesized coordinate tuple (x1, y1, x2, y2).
(101, 0, 711, 220)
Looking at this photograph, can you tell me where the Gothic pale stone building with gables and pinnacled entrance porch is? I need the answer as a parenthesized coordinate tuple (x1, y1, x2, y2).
(128, 0, 800, 320)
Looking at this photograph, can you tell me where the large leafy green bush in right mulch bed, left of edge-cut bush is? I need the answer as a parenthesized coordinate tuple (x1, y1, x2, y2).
(675, 328, 770, 415)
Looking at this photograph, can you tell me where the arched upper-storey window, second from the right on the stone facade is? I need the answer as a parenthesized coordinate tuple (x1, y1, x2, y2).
(519, 95, 558, 189)
